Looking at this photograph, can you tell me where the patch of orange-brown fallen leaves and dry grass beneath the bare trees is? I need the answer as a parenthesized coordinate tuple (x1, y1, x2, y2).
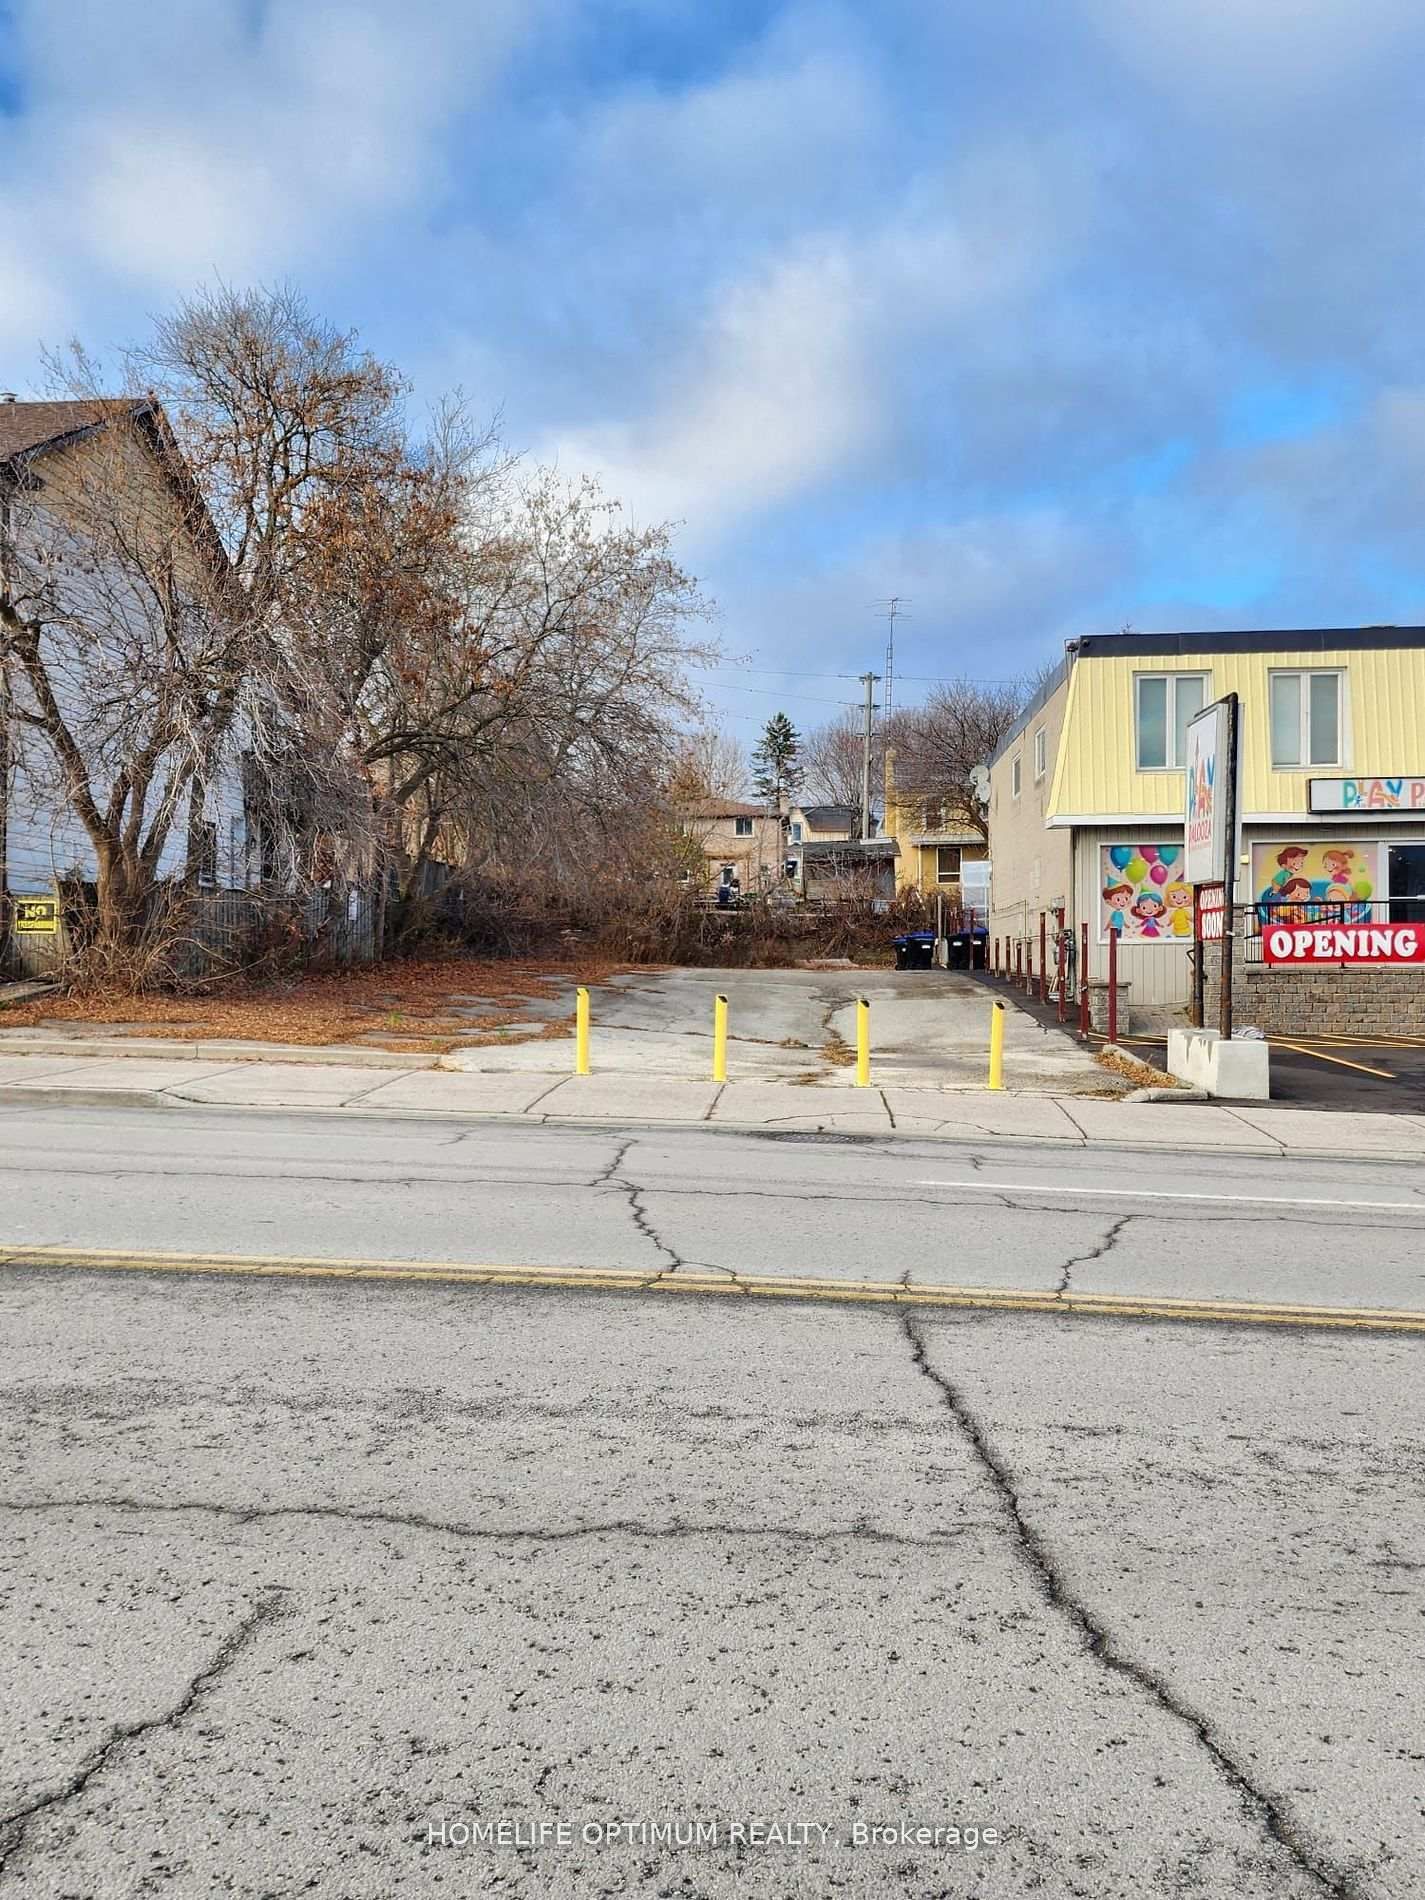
(2, 956, 625, 1053)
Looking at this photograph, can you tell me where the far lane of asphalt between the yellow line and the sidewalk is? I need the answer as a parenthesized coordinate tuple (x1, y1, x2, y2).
(0, 1106, 1425, 1309)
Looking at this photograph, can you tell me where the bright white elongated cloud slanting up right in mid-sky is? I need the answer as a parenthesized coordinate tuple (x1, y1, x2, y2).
(543, 127, 1091, 543)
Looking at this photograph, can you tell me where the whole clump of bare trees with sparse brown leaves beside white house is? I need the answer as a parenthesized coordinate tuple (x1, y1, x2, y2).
(0, 289, 737, 980)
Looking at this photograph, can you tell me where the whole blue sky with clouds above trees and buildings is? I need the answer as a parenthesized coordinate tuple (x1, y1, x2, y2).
(0, 0, 1425, 743)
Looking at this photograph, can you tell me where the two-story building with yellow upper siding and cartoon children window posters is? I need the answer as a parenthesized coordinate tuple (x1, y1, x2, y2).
(988, 627, 1425, 1030)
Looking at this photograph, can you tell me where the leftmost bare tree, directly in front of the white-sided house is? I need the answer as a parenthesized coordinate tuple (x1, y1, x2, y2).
(0, 399, 247, 958)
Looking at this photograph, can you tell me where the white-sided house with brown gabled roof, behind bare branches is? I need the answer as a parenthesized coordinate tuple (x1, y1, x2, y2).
(0, 397, 249, 967)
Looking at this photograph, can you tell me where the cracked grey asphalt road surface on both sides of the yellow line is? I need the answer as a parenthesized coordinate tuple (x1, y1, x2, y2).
(0, 1110, 1425, 1900)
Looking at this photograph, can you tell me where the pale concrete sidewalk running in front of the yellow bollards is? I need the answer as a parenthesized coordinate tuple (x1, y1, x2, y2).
(0, 1045, 1425, 1161)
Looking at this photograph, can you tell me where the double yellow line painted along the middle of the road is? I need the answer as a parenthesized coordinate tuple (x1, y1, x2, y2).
(0, 1246, 1425, 1334)
